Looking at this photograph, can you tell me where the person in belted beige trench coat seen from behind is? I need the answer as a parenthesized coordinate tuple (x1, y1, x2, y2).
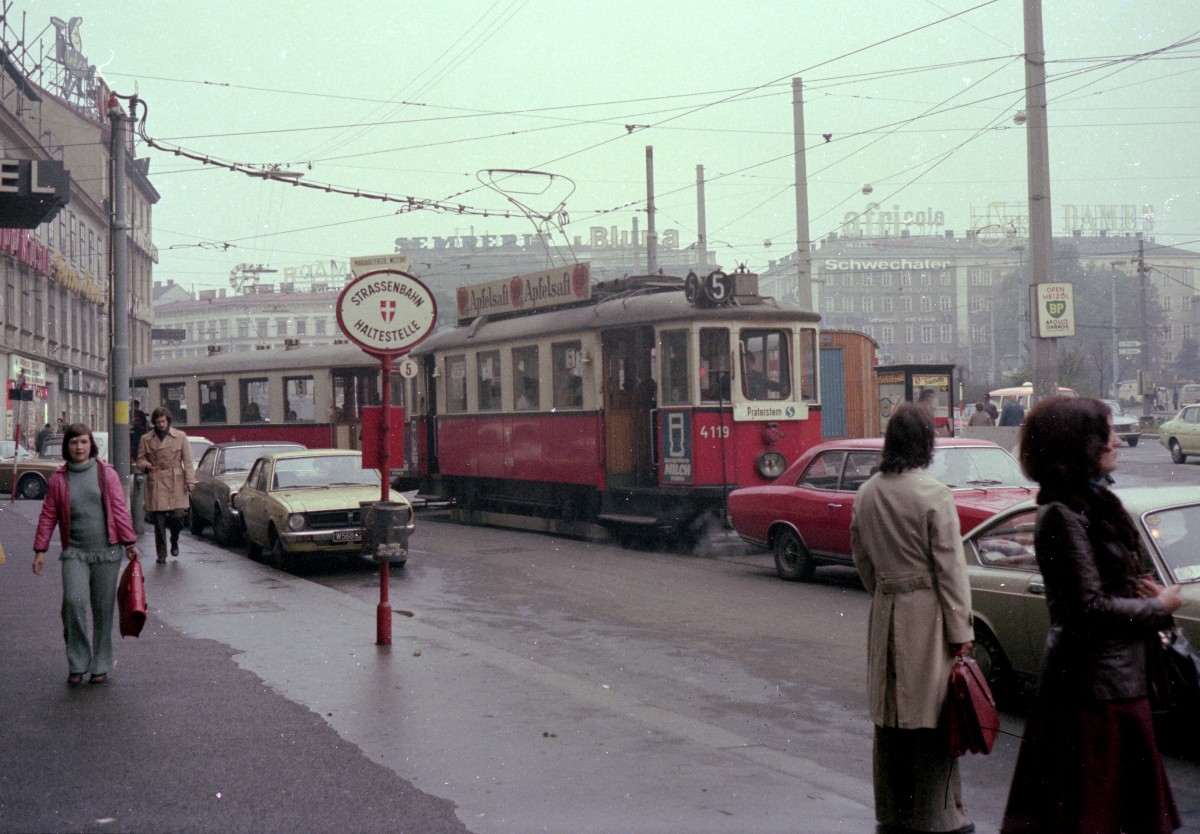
(851, 403, 974, 834)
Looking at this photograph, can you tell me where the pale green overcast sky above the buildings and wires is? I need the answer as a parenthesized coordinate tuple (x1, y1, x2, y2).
(25, 0, 1200, 288)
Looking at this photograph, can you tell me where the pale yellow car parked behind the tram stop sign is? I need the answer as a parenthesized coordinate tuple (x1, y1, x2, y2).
(235, 449, 413, 568)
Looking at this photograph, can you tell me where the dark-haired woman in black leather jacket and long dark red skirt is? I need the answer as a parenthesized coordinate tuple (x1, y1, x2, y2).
(1001, 396, 1183, 834)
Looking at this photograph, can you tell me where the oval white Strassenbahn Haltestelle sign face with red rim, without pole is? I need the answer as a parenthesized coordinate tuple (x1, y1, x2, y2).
(337, 269, 438, 356)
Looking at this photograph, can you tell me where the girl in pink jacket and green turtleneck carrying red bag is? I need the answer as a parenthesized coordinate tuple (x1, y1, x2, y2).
(34, 422, 138, 686)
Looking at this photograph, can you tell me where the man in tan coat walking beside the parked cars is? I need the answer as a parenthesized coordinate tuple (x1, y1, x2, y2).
(138, 406, 196, 564)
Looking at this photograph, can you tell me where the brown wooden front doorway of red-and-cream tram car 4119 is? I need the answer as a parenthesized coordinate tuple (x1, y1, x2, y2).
(602, 328, 658, 486)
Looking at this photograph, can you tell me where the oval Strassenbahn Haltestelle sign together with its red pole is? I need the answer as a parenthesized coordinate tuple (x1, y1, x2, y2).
(337, 269, 438, 646)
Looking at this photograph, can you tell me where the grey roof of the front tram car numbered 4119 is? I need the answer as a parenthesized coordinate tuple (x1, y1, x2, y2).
(413, 289, 821, 354)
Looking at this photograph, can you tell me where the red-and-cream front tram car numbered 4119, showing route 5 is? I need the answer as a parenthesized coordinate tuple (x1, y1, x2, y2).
(400, 272, 822, 538)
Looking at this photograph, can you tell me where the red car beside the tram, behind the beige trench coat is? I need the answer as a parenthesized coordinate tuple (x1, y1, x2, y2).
(730, 437, 1037, 580)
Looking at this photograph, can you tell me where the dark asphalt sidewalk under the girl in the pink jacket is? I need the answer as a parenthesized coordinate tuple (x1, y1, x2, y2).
(0, 496, 467, 834)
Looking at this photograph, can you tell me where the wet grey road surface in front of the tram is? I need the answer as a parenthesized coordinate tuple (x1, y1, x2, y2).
(0, 443, 1200, 834)
